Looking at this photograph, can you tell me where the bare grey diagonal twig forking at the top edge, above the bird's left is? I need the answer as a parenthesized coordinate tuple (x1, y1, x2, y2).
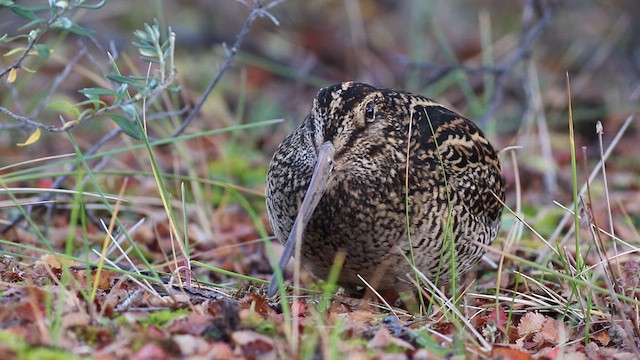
(171, 0, 284, 137)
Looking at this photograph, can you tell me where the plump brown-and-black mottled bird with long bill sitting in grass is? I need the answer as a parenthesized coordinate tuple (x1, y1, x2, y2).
(265, 82, 505, 296)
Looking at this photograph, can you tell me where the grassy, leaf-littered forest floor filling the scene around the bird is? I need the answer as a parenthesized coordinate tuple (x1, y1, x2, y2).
(0, 0, 640, 359)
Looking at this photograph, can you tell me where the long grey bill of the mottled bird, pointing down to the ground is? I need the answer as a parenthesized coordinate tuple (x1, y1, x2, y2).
(267, 141, 335, 297)
